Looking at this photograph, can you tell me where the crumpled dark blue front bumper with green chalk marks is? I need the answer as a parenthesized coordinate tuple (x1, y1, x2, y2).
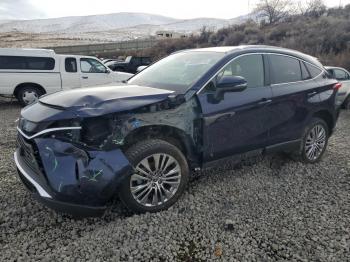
(14, 134, 132, 216)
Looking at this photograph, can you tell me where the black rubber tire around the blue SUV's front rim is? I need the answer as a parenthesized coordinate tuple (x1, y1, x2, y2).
(118, 139, 190, 213)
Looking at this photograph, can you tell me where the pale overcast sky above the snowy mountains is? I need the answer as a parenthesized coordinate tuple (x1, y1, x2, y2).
(0, 0, 350, 20)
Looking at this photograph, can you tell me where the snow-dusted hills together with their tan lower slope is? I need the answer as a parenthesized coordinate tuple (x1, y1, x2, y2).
(0, 13, 250, 47)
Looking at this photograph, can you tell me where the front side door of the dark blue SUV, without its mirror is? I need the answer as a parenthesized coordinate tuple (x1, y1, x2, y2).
(198, 54, 272, 162)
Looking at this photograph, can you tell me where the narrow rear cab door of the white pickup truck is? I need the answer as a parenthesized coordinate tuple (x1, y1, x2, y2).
(61, 56, 81, 89)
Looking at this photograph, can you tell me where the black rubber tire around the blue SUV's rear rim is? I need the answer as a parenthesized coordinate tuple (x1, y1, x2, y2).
(292, 118, 329, 164)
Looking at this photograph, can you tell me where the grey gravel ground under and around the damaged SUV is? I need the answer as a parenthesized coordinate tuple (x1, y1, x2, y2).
(0, 101, 350, 261)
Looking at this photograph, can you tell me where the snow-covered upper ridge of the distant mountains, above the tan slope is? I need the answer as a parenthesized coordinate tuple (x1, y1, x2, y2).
(0, 13, 249, 34)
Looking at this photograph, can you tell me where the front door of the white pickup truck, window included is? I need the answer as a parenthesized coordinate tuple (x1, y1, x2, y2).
(80, 57, 113, 87)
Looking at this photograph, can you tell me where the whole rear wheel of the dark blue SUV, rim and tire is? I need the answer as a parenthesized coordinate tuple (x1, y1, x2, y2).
(294, 118, 329, 163)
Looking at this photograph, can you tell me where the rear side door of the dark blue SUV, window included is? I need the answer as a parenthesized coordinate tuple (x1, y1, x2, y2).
(266, 54, 321, 145)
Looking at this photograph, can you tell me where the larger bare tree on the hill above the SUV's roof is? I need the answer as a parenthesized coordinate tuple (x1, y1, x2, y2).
(255, 0, 293, 24)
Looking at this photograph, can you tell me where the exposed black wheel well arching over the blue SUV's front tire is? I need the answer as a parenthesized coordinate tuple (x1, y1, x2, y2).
(123, 125, 198, 166)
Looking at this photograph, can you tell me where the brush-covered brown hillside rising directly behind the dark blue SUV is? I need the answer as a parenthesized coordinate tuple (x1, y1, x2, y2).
(135, 5, 350, 70)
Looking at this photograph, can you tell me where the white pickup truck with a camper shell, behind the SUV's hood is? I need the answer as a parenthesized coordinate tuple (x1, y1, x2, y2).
(0, 48, 132, 105)
